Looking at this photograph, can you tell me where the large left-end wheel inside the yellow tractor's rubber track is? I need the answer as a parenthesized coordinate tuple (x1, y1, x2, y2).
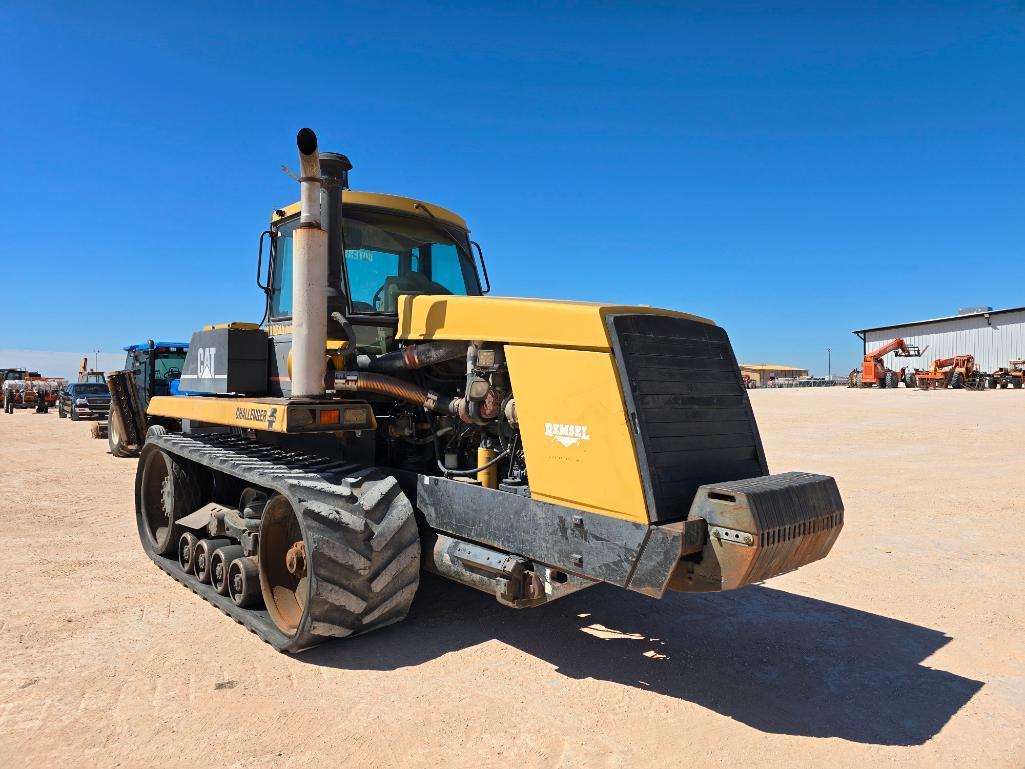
(135, 446, 200, 556)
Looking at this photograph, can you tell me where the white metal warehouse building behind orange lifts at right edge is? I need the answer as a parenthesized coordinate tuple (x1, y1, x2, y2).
(854, 307, 1025, 371)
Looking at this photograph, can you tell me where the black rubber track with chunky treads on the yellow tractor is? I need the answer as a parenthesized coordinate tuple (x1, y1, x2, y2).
(147, 433, 420, 651)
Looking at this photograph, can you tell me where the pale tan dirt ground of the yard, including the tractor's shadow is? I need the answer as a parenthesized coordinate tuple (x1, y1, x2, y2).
(0, 389, 1025, 769)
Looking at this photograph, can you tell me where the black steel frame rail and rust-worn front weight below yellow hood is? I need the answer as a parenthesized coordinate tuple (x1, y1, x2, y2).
(412, 473, 844, 598)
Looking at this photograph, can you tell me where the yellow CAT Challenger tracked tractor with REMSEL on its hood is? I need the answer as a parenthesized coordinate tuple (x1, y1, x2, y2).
(136, 129, 843, 651)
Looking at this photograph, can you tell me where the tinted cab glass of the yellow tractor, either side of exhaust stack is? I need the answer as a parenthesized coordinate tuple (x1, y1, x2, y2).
(271, 206, 480, 318)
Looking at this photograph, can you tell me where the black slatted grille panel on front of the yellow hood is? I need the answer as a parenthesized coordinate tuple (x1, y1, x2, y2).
(609, 315, 769, 522)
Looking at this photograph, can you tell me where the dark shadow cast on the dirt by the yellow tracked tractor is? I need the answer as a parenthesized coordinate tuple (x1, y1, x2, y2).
(298, 574, 982, 745)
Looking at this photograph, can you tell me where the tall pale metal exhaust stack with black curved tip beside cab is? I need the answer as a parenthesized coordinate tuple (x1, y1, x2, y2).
(292, 128, 328, 398)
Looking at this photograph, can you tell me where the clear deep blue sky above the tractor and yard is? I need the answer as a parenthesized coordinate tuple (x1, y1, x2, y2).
(0, 2, 1025, 373)
